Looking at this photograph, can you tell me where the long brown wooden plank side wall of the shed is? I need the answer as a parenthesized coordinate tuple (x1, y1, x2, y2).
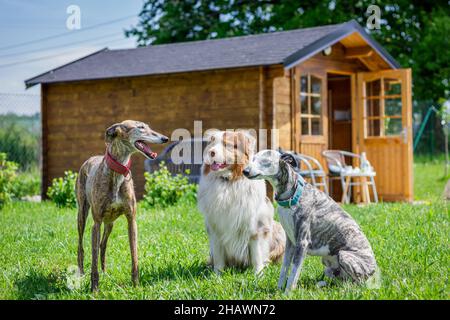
(42, 68, 262, 196)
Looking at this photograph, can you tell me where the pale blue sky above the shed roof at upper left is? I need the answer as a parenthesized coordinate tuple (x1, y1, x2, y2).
(0, 0, 143, 114)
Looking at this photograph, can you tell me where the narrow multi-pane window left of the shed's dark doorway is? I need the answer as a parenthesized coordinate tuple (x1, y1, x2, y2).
(300, 74, 323, 136)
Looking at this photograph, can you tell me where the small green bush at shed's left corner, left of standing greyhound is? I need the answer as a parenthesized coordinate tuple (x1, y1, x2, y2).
(47, 171, 77, 208)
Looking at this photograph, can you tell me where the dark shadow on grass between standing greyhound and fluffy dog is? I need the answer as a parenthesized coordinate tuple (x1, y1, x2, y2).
(140, 261, 214, 284)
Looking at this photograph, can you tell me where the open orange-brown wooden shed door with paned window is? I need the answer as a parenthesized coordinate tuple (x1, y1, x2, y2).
(357, 69, 413, 201)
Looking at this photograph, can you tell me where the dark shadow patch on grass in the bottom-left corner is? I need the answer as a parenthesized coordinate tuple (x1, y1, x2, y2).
(14, 270, 69, 300)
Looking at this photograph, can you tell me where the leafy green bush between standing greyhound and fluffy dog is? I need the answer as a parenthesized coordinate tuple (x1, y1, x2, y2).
(143, 162, 197, 208)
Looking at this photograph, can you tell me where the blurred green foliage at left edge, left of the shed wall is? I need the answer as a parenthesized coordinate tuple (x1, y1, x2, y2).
(0, 114, 40, 170)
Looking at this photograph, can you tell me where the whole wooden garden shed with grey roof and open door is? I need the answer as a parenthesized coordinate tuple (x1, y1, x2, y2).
(26, 21, 413, 201)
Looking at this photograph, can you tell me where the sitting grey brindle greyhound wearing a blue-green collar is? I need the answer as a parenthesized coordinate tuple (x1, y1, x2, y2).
(244, 150, 377, 292)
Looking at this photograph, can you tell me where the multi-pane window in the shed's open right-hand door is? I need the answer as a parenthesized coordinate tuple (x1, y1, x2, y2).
(363, 78, 403, 137)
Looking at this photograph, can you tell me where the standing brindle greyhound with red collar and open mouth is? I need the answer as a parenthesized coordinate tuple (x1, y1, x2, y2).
(76, 120, 169, 291)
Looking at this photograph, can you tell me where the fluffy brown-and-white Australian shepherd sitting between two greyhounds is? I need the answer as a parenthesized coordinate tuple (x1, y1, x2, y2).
(198, 130, 286, 273)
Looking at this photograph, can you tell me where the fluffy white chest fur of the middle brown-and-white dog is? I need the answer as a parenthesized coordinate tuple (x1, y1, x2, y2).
(198, 174, 273, 264)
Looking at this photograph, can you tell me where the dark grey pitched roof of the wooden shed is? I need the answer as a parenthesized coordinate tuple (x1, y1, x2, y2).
(25, 20, 399, 87)
